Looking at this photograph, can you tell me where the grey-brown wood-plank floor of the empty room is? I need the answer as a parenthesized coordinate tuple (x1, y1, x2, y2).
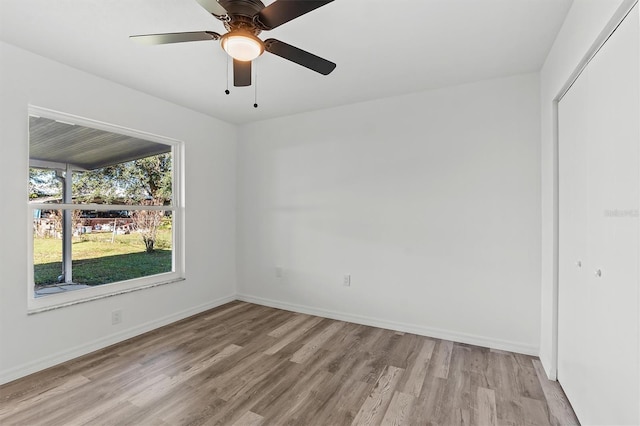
(0, 302, 577, 426)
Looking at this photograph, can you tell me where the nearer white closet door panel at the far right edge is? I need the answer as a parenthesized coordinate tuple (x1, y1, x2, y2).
(584, 7, 640, 424)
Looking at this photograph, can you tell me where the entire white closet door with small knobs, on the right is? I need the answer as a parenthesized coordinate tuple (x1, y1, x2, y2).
(558, 6, 640, 425)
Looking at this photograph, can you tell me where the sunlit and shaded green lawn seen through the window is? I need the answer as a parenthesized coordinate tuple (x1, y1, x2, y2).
(33, 230, 171, 286)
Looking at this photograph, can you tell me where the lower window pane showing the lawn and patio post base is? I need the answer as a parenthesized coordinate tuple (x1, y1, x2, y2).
(33, 210, 173, 296)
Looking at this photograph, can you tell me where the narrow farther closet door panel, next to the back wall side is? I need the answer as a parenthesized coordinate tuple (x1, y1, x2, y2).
(558, 68, 589, 418)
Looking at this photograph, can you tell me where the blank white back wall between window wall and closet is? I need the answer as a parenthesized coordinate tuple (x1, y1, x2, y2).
(238, 74, 540, 354)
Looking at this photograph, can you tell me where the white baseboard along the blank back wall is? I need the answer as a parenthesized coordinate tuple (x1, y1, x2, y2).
(236, 294, 539, 356)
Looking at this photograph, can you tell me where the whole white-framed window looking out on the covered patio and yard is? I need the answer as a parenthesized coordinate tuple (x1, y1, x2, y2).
(28, 107, 184, 312)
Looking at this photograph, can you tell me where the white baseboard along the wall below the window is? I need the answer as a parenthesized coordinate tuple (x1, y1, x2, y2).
(0, 294, 236, 385)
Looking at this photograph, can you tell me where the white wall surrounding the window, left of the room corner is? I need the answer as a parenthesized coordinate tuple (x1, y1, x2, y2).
(0, 42, 237, 383)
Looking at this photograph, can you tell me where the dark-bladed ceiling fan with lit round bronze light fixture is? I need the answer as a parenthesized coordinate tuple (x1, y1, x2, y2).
(130, 0, 336, 87)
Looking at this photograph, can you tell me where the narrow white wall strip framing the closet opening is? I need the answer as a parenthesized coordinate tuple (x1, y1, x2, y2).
(540, 0, 630, 378)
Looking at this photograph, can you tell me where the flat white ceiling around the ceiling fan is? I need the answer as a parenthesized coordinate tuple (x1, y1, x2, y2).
(0, 0, 572, 123)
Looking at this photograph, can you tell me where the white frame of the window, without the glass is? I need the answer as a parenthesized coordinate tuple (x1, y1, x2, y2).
(25, 105, 185, 314)
